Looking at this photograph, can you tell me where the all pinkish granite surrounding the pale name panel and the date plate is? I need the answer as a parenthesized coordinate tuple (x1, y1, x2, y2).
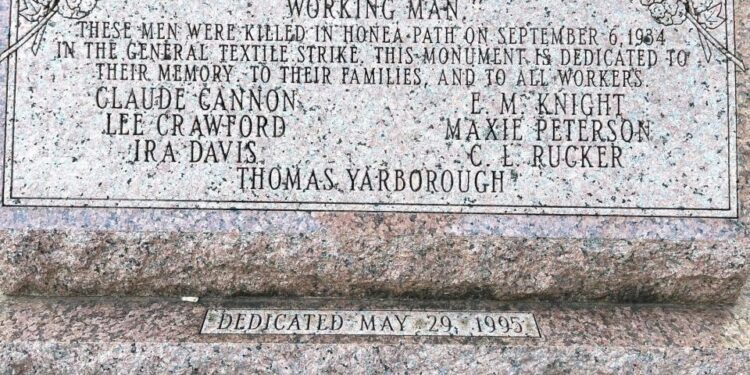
(0, 0, 750, 374)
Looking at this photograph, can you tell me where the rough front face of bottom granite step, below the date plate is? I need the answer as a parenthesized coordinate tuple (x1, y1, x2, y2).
(0, 343, 750, 374)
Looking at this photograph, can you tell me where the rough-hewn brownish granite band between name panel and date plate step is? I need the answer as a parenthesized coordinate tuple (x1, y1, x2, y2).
(0, 231, 750, 303)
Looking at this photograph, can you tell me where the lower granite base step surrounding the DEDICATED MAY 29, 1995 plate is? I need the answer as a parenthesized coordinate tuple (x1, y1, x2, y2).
(0, 296, 750, 374)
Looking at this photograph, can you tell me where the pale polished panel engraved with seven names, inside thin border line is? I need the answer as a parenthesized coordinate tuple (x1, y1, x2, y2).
(3, 0, 744, 218)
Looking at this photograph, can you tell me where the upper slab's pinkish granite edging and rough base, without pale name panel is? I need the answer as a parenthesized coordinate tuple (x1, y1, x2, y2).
(0, 0, 750, 303)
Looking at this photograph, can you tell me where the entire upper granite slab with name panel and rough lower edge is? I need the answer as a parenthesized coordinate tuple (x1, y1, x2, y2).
(0, 0, 750, 302)
